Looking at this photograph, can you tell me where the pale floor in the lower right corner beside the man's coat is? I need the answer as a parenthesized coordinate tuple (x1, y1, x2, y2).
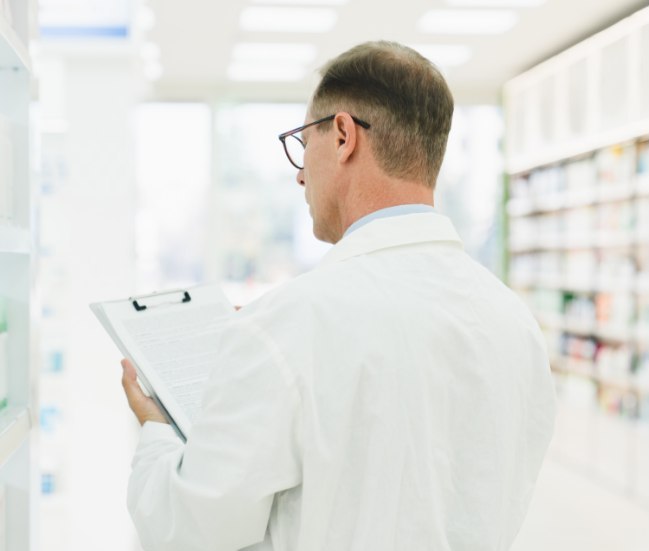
(511, 458, 649, 551)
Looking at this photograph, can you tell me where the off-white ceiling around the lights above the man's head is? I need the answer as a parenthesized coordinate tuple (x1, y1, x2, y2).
(140, 0, 649, 103)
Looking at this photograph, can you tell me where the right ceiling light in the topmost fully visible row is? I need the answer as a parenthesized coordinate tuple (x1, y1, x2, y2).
(417, 10, 518, 34)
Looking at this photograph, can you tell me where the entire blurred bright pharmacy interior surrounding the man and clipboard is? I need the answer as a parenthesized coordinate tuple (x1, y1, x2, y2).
(0, 0, 649, 551)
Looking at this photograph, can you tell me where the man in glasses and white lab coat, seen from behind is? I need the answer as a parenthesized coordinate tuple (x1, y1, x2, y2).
(123, 42, 554, 551)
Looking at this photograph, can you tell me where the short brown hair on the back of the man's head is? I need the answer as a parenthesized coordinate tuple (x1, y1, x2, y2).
(311, 41, 453, 188)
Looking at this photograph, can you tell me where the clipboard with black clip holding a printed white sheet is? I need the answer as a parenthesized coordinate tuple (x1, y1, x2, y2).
(90, 284, 235, 440)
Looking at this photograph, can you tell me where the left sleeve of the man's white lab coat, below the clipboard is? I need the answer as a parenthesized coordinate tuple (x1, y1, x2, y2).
(128, 323, 301, 551)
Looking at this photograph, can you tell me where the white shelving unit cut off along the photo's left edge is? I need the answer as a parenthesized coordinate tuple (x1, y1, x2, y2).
(0, 0, 37, 551)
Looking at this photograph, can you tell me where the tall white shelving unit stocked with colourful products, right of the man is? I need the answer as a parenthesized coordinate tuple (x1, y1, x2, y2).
(504, 8, 649, 506)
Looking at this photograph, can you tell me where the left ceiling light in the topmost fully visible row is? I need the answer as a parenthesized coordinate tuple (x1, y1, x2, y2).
(239, 7, 337, 33)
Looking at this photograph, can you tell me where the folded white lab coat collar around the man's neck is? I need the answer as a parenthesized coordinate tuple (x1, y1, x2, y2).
(318, 212, 462, 267)
